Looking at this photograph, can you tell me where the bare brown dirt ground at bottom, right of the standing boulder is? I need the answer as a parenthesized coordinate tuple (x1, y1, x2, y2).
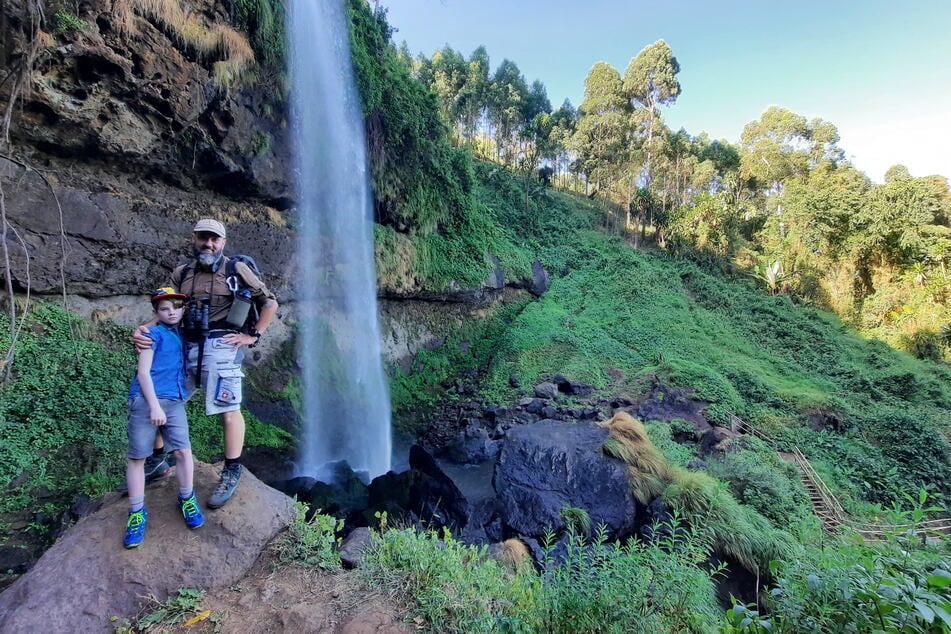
(160, 547, 416, 634)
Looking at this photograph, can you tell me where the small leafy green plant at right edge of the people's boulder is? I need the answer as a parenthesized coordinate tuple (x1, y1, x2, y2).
(277, 502, 343, 570)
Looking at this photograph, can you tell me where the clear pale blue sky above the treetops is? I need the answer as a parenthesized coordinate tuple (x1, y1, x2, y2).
(380, 0, 951, 181)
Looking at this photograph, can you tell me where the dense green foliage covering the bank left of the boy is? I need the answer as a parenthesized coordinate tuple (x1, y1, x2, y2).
(0, 303, 135, 510)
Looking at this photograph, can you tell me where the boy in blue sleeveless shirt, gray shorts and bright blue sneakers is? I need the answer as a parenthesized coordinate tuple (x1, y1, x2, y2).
(123, 288, 205, 548)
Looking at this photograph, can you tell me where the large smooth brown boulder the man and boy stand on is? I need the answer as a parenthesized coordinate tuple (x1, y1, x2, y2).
(0, 463, 294, 634)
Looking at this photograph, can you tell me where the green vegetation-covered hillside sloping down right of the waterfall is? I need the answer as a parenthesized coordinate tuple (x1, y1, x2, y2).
(394, 158, 951, 504)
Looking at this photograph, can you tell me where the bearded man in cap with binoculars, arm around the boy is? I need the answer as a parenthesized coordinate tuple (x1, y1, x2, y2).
(134, 218, 278, 509)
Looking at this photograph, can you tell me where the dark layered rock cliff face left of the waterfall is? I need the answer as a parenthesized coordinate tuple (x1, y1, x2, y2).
(0, 0, 293, 308)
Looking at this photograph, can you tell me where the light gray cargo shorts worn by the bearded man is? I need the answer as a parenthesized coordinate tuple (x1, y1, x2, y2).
(187, 337, 244, 415)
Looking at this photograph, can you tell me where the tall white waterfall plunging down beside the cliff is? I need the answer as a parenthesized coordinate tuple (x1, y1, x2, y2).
(287, 0, 391, 481)
